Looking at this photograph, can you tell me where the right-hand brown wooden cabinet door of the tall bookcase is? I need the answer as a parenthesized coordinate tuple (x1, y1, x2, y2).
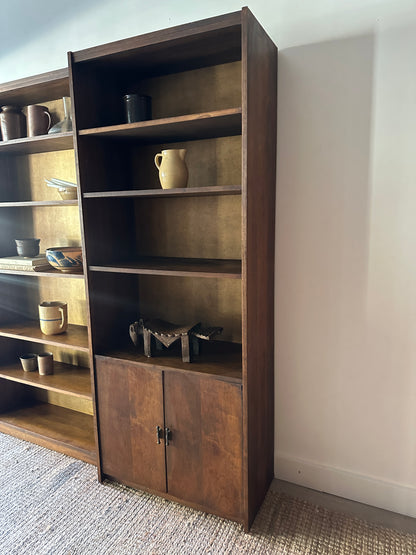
(164, 372, 243, 520)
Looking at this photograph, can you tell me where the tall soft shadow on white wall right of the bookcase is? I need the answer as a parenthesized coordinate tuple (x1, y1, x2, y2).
(276, 35, 374, 462)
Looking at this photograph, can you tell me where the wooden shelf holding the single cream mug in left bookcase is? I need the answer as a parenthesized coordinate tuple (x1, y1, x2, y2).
(0, 320, 89, 352)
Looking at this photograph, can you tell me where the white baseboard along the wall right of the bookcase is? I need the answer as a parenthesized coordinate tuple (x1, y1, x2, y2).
(275, 454, 416, 518)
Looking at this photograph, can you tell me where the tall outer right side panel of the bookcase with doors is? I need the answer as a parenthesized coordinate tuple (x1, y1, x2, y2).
(242, 8, 277, 528)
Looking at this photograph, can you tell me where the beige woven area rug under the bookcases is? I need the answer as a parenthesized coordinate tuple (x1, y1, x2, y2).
(0, 434, 416, 555)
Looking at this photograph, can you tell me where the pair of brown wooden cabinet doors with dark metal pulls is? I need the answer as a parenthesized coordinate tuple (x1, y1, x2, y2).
(96, 356, 243, 520)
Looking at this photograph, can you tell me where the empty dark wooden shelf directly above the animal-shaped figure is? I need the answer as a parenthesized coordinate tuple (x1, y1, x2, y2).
(89, 256, 241, 279)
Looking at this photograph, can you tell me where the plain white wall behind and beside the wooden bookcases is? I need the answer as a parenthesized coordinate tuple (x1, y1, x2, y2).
(0, 0, 416, 516)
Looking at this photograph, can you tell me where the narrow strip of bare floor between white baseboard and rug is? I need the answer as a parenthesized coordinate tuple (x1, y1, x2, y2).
(271, 479, 416, 534)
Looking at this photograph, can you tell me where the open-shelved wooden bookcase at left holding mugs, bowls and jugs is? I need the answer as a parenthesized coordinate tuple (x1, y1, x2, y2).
(0, 69, 97, 464)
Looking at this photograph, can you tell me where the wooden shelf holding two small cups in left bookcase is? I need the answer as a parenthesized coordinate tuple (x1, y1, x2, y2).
(0, 361, 92, 399)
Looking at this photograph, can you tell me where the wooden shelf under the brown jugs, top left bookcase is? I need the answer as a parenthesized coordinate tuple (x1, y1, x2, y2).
(0, 132, 74, 155)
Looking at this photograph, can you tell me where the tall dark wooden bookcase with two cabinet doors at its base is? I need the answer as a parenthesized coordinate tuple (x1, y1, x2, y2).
(66, 8, 277, 529)
